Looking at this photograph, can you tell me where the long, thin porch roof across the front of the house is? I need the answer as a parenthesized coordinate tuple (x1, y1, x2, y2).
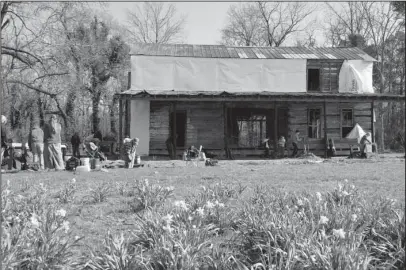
(116, 90, 405, 102)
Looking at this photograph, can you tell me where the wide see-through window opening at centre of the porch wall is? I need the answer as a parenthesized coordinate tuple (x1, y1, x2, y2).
(237, 115, 266, 147)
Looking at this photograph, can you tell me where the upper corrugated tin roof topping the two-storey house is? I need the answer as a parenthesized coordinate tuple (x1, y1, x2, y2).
(130, 43, 376, 61)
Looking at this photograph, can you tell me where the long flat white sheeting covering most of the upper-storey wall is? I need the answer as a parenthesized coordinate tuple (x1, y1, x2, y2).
(131, 55, 306, 92)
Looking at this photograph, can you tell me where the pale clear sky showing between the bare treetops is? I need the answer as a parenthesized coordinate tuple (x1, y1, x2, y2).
(106, 2, 323, 46)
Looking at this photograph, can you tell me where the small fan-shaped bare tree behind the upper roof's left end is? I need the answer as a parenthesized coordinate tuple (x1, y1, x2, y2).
(127, 2, 186, 43)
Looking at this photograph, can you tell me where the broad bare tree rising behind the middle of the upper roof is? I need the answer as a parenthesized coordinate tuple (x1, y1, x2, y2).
(222, 2, 315, 47)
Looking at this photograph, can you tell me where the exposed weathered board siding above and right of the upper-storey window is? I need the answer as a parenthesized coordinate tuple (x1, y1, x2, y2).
(307, 59, 343, 93)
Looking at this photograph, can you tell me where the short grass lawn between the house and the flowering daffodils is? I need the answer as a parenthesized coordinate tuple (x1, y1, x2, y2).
(2, 154, 405, 268)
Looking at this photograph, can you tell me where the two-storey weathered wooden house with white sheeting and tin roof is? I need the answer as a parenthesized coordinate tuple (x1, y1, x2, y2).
(118, 44, 404, 158)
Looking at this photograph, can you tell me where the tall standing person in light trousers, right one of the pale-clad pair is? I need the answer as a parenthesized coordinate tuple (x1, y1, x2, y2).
(44, 114, 65, 171)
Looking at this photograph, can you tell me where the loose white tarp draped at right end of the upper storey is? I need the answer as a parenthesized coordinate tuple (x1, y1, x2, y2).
(338, 60, 374, 93)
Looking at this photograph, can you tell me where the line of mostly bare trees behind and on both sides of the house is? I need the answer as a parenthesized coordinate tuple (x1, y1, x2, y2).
(0, 1, 405, 150)
